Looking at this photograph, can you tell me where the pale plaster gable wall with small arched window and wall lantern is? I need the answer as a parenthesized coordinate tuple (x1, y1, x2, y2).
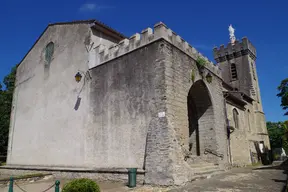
(7, 24, 118, 167)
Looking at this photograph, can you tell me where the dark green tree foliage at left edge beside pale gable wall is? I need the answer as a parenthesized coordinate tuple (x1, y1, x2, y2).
(0, 67, 16, 155)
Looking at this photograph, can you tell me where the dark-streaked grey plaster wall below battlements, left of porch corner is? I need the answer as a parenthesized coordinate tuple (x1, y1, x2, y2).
(86, 40, 165, 168)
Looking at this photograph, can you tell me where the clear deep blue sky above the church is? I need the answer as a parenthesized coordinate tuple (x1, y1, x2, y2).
(0, 0, 288, 121)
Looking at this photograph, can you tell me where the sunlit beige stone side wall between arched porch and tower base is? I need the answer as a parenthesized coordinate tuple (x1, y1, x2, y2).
(227, 100, 270, 166)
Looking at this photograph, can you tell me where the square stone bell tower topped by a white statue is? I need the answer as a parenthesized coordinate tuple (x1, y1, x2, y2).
(213, 25, 267, 136)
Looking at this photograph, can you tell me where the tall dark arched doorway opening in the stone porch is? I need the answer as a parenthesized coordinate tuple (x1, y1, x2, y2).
(187, 80, 216, 158)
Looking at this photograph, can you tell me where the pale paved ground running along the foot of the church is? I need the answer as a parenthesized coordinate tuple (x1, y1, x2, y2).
(0, 166, 288, 192)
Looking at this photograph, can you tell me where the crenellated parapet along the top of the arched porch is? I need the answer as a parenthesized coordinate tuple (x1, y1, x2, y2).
(89, 22, 221, 76)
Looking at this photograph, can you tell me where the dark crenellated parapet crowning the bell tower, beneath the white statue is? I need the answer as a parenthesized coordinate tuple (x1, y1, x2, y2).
(213, 37, 256, 63)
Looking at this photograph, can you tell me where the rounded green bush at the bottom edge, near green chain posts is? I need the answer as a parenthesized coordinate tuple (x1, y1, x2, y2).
(62, 179, 100, 192)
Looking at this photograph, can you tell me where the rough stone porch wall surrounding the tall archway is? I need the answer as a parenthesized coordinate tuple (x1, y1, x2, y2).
(145, 41, 227, 184)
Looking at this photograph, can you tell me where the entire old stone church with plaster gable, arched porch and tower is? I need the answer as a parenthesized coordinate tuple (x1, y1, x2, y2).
(7, 20, 270, 185)
